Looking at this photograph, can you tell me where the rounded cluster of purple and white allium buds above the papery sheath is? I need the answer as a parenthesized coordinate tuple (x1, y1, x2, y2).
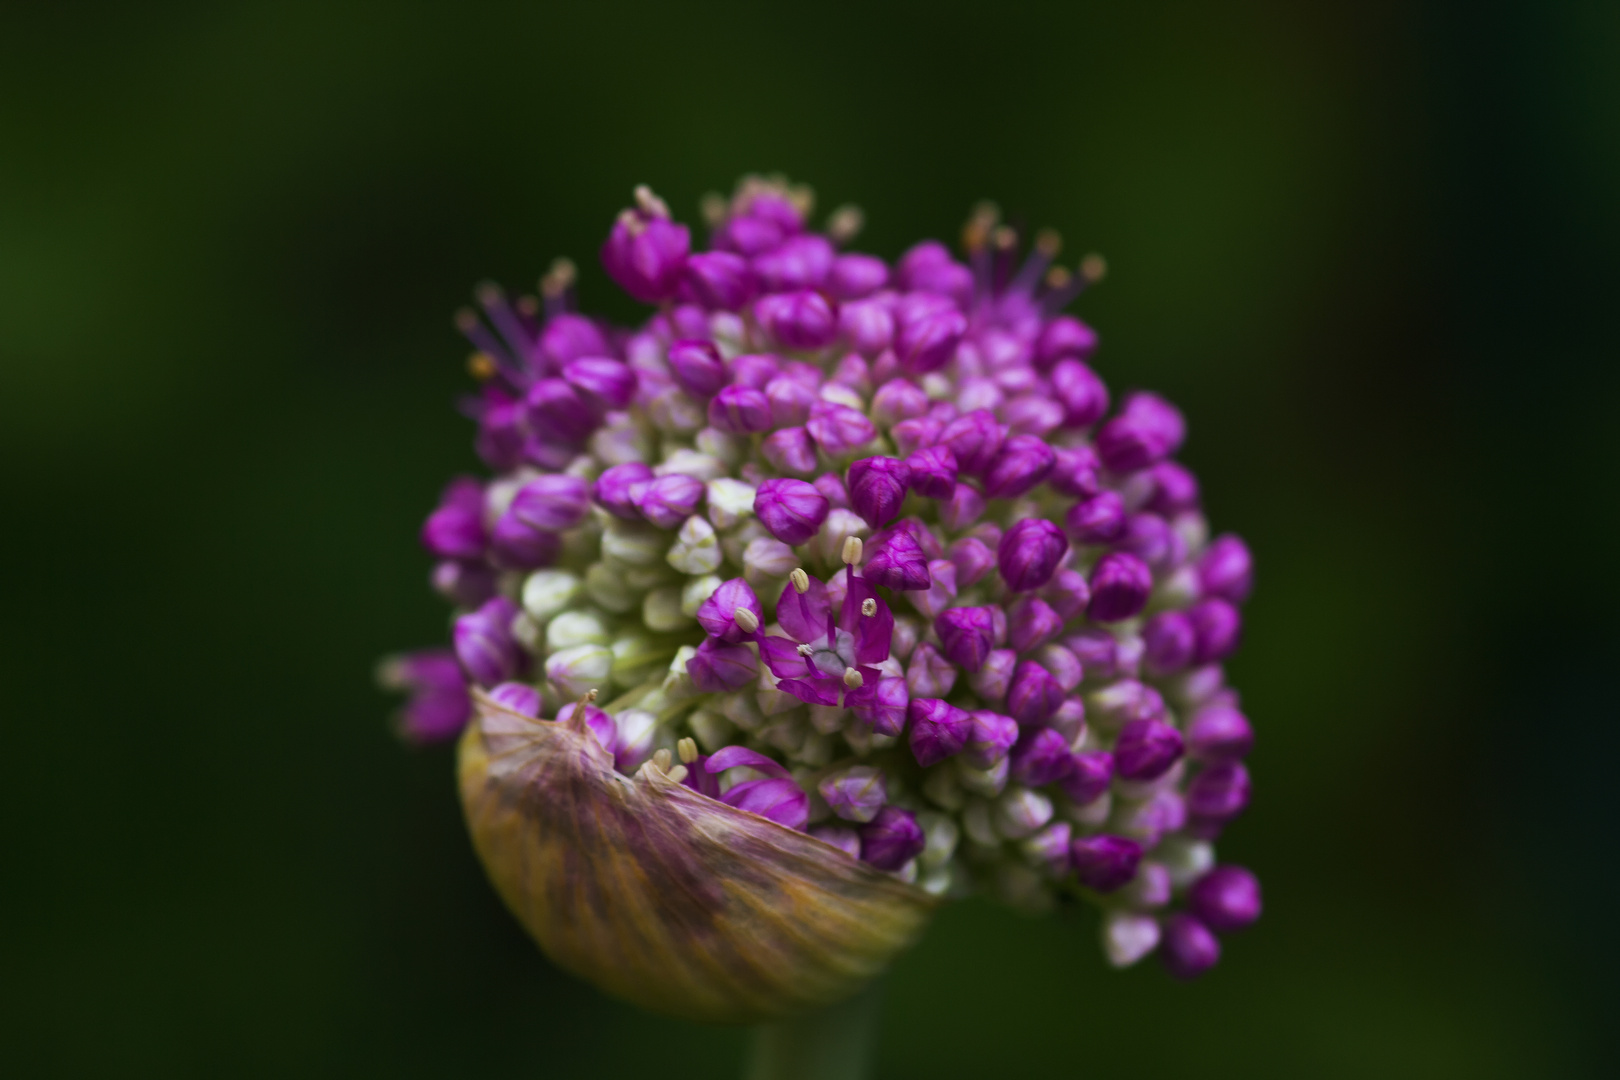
(384, 178, 1260, 978)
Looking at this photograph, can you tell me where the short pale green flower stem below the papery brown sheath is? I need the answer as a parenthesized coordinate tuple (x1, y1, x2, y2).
(742, 980, 883, 1080)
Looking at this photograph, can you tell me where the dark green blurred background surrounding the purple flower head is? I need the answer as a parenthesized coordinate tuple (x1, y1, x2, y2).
(0, 0, 1620, 1080)
